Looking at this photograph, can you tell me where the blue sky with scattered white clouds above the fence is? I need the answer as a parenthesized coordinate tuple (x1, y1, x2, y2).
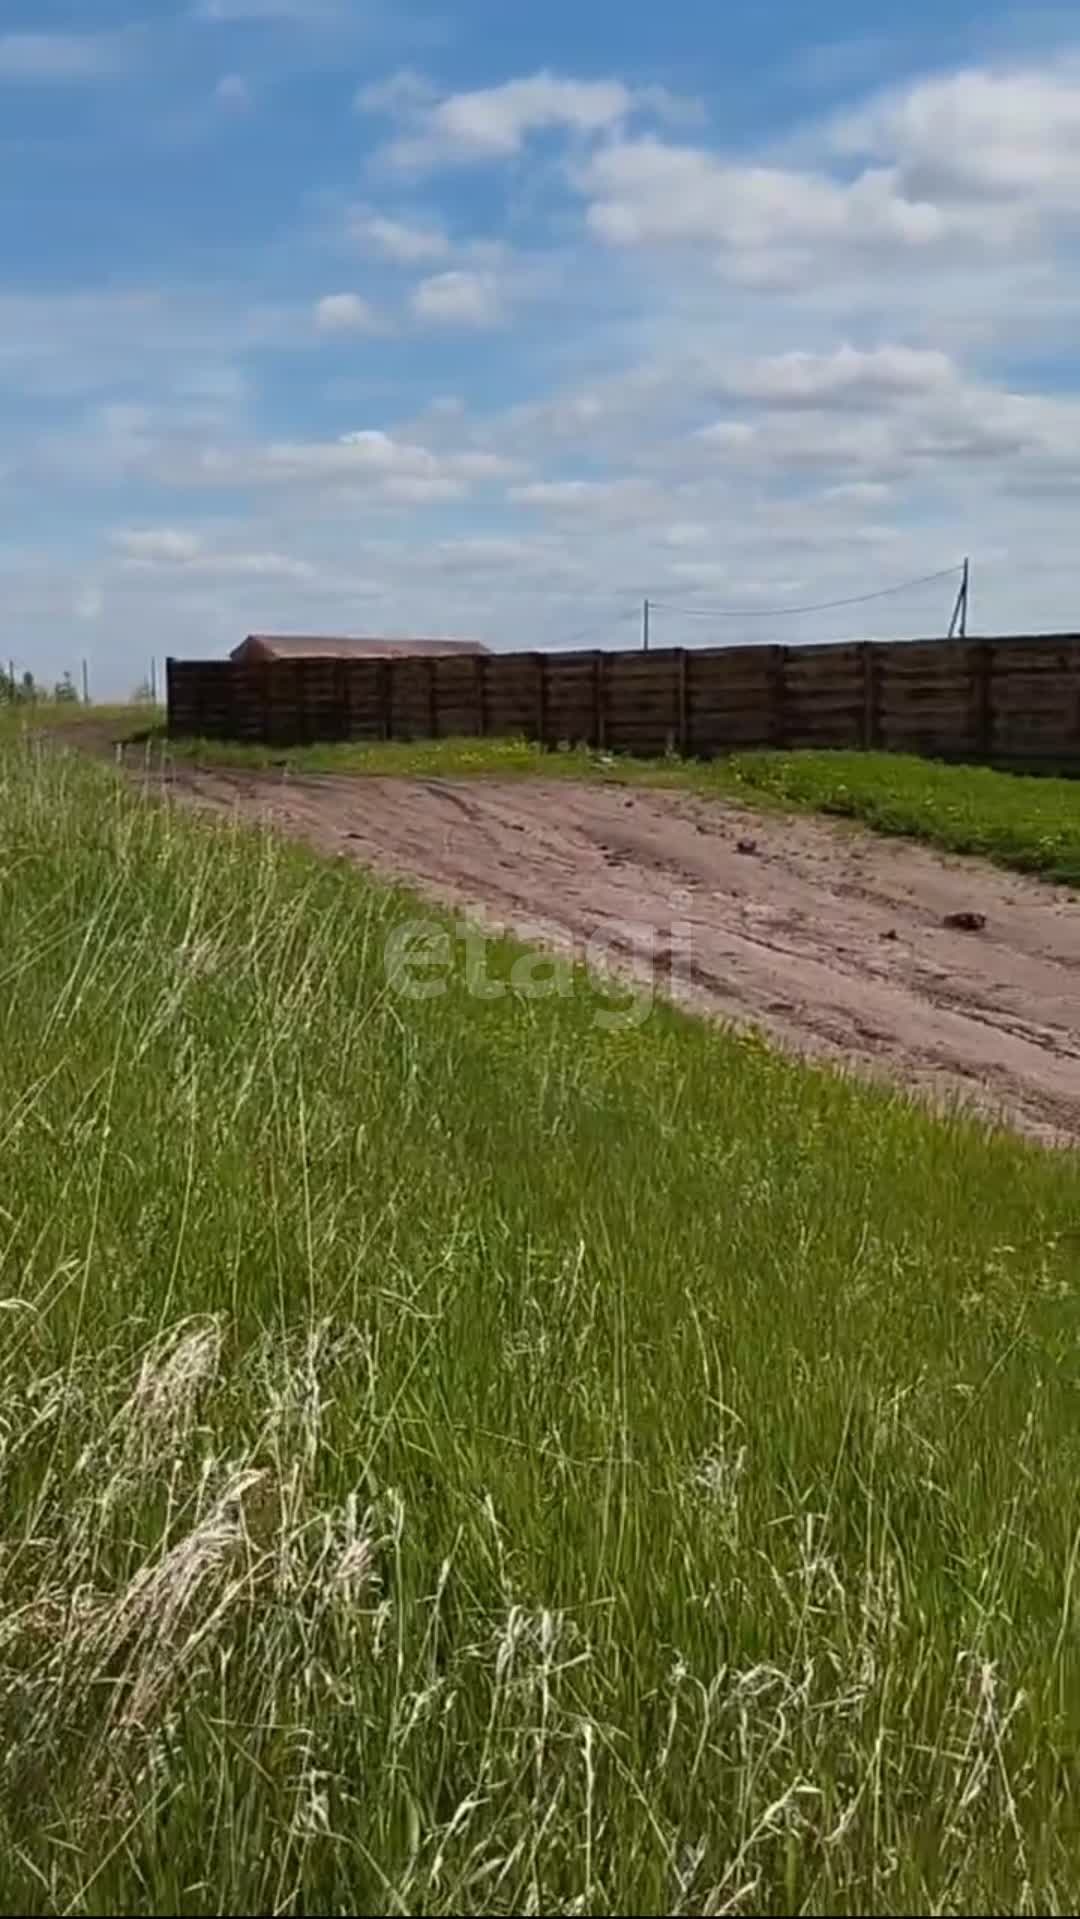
(0, 0, 1080, 693)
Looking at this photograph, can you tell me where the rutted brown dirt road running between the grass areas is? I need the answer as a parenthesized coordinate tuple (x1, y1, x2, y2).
(154, 768, 1080, 1142)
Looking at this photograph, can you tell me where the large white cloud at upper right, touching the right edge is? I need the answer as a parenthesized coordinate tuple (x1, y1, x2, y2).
(574, 54, 1080, 299)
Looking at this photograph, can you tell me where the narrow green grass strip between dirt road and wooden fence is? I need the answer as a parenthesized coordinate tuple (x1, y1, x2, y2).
(154, 721, 1080, 887)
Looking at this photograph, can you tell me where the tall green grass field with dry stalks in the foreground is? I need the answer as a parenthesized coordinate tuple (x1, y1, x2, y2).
(0, 737, 1080, 1913)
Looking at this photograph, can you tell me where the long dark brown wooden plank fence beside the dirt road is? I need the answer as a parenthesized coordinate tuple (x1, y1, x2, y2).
(169, 633, 1080, 764)
